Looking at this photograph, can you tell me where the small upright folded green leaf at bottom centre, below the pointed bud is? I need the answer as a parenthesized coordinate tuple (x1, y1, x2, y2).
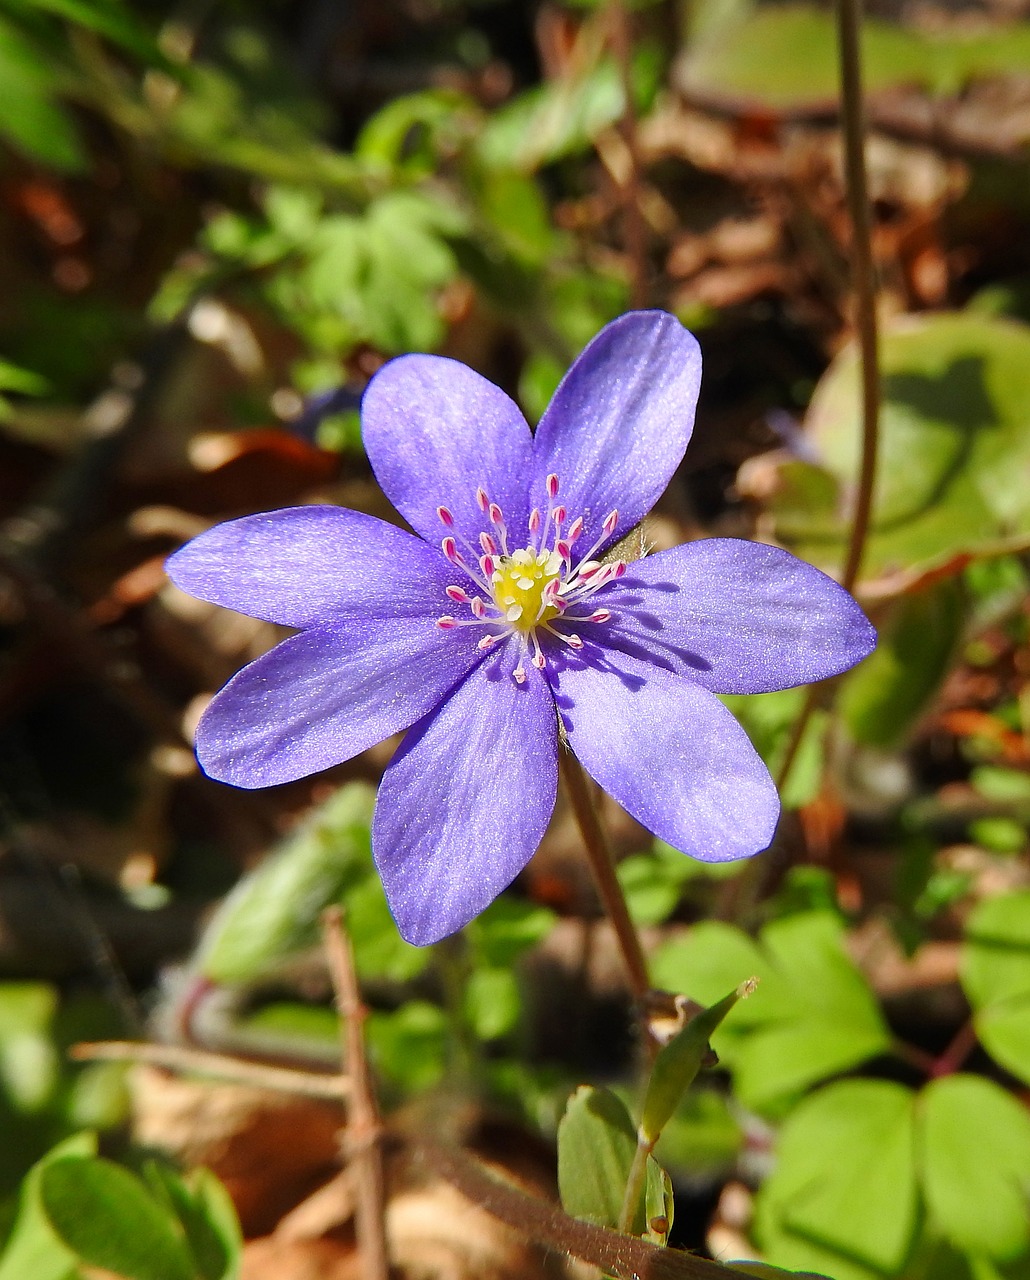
(558, 1085, 644, 1235)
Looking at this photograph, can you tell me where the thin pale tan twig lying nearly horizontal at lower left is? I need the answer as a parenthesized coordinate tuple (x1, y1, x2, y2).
(68, 1041, 351, 1102)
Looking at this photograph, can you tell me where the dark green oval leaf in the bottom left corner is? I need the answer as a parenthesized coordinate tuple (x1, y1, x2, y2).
(40, 1156, 196, 1280)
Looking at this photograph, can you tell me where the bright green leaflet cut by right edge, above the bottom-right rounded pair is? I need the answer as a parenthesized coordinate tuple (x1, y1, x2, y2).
(960, 890, 1030, 1084)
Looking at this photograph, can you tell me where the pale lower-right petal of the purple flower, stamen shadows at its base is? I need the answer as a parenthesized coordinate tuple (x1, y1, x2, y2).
(548, 652, 779, 863)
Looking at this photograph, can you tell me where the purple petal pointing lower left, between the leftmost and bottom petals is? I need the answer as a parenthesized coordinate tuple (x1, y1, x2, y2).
(197, 618, 482, 787)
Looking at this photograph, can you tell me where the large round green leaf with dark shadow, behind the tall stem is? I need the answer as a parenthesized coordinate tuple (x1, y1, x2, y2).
(772, 314, 1030, 586)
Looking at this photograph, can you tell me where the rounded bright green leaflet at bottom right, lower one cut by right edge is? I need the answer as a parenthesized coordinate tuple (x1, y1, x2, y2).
(919, 1075, 1030, 1262)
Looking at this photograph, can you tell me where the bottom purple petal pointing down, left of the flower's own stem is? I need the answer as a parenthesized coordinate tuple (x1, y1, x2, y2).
(372, 645, 558, 946)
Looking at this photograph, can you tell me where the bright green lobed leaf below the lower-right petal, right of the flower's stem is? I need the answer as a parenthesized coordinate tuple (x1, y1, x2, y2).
(653, 911, 891, 1111)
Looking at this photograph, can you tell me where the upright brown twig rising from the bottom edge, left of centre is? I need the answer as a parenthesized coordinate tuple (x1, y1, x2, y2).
(322, 906, 390, 1280)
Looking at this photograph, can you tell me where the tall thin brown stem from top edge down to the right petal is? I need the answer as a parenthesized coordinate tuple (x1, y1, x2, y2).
(836, 0, 880, 591)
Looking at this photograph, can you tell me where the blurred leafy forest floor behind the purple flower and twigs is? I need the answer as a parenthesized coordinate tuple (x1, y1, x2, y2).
(0, 0, 1030, 1280)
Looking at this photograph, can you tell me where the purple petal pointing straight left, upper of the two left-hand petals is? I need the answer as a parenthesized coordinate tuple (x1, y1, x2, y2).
(166, 507, 461, 627)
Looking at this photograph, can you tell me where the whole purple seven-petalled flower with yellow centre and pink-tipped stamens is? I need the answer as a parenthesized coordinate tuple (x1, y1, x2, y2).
(168, 311, 874, 943)
